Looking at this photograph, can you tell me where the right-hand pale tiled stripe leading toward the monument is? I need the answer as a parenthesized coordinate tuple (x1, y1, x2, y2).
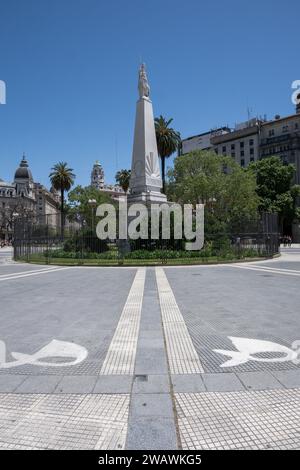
(155, 268, 204, 374)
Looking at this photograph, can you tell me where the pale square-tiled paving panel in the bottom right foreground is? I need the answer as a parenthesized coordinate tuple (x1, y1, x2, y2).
(176, 389, 300, 450)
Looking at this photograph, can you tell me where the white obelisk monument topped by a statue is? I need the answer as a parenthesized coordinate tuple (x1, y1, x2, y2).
(128, 64, 167, 204)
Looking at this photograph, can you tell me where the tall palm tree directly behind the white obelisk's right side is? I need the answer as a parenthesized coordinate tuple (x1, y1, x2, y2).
(154, 116, 181, 192)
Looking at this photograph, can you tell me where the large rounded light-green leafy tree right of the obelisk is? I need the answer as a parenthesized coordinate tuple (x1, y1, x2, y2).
(168, 151, 259, 236)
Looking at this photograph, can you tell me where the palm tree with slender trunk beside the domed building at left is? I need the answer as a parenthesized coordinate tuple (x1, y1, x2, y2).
(49, 162, 76, 238)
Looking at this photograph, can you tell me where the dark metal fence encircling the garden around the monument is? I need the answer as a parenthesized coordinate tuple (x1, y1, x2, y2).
(13, 213, 279, 264)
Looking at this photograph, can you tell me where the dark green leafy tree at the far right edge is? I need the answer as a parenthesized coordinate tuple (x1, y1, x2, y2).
(248, 157, 300, 231)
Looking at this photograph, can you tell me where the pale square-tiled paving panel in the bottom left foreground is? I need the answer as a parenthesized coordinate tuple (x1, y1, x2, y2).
(0, 394, 130, 450)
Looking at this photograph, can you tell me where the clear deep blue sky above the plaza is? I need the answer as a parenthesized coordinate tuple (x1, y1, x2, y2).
(0, 0, 300, 185)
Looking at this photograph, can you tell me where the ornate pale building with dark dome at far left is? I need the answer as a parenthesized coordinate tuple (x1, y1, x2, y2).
(0, 155, 59, 242)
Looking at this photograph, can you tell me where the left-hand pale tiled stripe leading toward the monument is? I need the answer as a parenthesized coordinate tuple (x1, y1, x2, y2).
(100, 268, 146, 375)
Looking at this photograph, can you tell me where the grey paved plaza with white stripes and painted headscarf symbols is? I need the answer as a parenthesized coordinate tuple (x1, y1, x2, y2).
(0, 247, 300, 450)
